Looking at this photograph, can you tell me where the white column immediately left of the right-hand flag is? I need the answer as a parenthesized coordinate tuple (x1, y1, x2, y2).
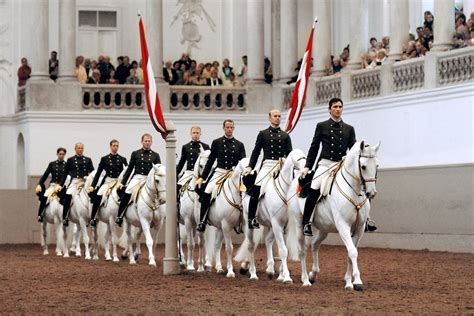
(280, 0, 298, 82)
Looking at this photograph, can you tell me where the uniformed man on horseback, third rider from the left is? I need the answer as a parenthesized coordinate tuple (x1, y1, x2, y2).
(87, 139, 128, 227)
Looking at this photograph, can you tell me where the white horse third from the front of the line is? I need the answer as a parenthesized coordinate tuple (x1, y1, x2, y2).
(202, 158, 249, 278)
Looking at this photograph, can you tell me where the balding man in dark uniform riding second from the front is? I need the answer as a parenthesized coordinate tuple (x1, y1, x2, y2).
(243, 109, 292, 229)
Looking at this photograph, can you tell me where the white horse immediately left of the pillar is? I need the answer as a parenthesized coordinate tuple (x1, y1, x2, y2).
(125, 164, 166, 267)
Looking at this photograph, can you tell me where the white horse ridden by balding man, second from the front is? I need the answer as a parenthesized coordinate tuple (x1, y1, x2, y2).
(236, 149, 306, 283)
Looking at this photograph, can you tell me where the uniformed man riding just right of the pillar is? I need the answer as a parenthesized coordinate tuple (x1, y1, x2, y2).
(176, 126, 209, 200)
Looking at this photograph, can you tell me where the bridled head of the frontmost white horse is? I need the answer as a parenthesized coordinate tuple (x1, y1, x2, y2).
(348, 141, 380, 199)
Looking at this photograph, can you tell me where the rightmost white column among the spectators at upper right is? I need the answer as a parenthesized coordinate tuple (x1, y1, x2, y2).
(432, 0, 454, 51)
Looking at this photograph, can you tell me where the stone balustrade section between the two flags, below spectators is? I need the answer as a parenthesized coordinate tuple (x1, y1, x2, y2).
(169, 86, 247, 111)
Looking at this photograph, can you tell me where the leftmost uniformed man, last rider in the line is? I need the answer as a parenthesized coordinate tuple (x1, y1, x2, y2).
(35, 147, 66, 223)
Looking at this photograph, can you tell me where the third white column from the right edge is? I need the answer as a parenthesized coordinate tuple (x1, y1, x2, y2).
(346, 0, 368, 70)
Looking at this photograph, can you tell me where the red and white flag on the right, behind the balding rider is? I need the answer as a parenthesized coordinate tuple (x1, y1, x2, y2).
(286, 18, 318, 133)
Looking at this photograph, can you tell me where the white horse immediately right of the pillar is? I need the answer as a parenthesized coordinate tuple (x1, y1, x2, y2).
(179, 150, 211, 272)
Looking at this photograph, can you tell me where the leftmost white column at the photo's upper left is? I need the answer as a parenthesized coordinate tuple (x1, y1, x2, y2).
(28, 0, 49, 81)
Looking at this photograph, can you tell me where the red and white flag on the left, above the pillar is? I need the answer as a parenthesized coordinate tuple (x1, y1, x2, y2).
(138, 16, 168, 139)
